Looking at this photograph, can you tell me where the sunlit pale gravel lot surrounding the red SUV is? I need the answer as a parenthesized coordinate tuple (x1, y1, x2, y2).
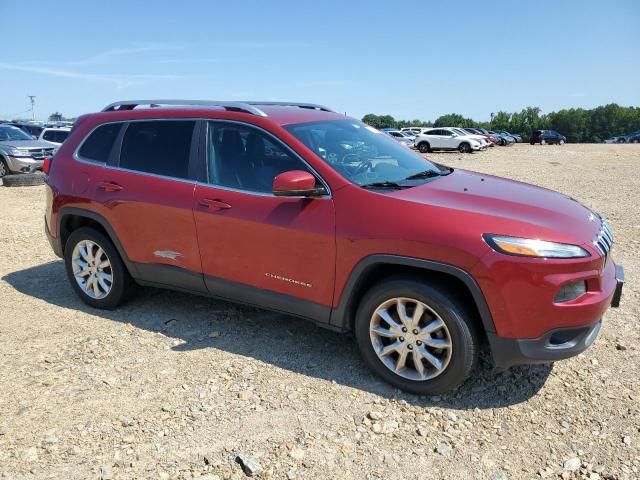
(0, 145, 640, 480)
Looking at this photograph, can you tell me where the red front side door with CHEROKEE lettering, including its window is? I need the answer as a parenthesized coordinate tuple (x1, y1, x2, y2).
(193, 121, 336, 321)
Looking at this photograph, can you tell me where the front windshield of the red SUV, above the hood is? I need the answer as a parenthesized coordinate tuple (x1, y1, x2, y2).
(284, 120, 442, 187)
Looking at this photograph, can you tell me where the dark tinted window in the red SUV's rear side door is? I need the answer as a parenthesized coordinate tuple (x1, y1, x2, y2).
(120, 121, 196, 178)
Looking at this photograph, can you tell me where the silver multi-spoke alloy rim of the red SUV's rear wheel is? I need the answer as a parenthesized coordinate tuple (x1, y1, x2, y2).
(71, 240, 113, 300)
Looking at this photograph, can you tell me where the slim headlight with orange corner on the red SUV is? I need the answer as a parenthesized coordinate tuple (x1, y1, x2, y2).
(483, 233, 589, 258)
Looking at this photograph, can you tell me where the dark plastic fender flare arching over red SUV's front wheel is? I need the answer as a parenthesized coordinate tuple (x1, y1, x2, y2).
(331, 254, 495, 333)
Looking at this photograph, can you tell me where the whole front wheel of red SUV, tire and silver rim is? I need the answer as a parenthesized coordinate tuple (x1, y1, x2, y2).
(355, 278, 479, 395)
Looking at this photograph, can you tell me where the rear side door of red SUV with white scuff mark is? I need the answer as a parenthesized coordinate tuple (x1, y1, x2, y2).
(92, 120, 205, 292)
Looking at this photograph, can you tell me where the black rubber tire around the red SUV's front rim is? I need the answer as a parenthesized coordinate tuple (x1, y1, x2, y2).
(354, 278, 479, 395)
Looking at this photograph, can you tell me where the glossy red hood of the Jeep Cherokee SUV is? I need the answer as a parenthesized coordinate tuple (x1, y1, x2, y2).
(392, 170, 600, 244)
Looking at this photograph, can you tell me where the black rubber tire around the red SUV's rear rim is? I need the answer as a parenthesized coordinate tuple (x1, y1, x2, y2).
(64, 227, 135, 310)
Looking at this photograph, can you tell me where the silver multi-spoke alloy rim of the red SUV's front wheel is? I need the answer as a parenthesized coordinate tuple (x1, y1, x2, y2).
(369, 297, 453, 381)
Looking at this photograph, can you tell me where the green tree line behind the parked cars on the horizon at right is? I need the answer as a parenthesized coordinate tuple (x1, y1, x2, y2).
(362, 103, 640, 143)
